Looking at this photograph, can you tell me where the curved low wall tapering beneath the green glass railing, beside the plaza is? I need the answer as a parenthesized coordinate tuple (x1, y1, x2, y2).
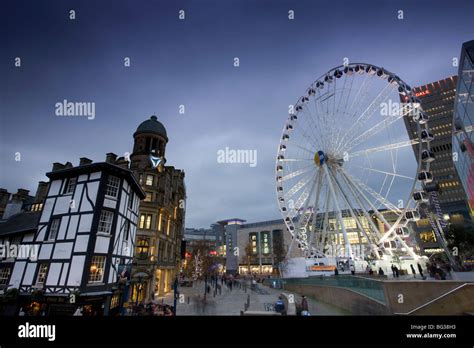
(284, 284, 390, 315)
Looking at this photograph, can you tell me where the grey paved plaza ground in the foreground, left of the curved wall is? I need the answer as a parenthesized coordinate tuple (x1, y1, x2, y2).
(158, 281, 349, 316)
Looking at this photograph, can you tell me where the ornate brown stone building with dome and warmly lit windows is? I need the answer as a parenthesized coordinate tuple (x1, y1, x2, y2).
(130, 116, 186, 302)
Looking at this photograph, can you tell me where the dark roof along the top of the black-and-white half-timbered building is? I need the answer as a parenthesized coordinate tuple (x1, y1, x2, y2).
(46, 162, 146, 199)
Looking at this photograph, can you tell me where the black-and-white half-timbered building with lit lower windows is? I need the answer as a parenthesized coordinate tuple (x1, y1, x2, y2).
(8, 154, 145, 315)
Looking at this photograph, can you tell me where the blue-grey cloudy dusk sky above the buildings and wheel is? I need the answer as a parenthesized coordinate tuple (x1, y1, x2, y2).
(0, 0, 474, 228)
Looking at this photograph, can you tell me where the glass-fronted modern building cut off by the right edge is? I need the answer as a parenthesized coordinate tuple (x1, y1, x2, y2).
(453, 40, 474, 218)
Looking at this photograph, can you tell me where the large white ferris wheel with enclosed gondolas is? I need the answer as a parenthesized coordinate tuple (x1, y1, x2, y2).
(276, 63, 434, 259)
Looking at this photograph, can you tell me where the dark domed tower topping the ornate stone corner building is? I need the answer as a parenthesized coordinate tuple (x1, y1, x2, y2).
(130, 115, 168, 171)
